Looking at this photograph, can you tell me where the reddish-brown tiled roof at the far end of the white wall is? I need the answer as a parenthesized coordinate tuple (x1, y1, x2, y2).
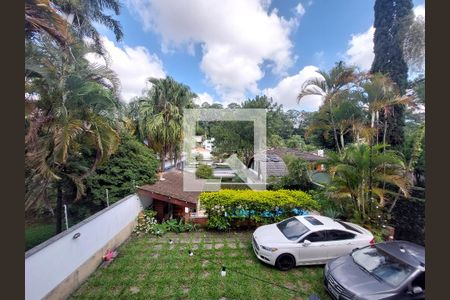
(138, 170, 200, 204)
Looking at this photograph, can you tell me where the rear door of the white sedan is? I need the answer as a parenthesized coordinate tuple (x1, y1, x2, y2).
(326, 229, 358, 259)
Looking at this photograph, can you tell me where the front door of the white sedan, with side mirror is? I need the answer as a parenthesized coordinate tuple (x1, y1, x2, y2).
(297, 230, 327, 264)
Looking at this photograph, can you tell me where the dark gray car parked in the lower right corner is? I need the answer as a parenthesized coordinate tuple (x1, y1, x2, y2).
(324, 241, 425, 300)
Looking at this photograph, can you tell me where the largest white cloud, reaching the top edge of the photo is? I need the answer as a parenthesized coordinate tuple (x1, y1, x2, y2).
(127, 0, 298, 98)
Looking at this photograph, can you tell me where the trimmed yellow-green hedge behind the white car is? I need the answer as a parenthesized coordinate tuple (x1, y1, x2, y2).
(199, 189, 320, 230)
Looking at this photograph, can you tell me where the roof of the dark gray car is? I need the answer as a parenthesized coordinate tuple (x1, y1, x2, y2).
(375, 241, 425, 268)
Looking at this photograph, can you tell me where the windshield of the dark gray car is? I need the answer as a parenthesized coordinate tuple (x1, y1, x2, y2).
(352, 247, 414, 286)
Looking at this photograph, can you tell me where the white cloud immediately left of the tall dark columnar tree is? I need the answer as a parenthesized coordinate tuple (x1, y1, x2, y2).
(345, 26, 375, 71)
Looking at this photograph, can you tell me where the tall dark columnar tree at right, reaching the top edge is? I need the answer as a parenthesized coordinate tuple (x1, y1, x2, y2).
(371, 0, 414, 148)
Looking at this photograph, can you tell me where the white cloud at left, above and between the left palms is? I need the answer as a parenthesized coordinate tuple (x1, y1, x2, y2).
(86, 37, 166, 102)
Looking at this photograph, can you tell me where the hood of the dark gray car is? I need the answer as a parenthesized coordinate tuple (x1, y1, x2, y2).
(328, 255, 393, 296)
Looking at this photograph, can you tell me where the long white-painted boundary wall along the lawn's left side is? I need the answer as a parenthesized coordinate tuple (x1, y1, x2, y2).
(25, 194, 148, 300)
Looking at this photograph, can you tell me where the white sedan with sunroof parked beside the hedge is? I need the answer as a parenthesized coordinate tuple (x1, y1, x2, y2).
(252, 215, 375, 271)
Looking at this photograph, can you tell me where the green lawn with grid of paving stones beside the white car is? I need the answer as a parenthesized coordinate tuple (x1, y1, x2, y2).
(71, 231, 329, 300)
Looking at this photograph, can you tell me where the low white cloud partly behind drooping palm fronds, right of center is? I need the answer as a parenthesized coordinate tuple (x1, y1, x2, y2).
(263, 66, 322, 111)
